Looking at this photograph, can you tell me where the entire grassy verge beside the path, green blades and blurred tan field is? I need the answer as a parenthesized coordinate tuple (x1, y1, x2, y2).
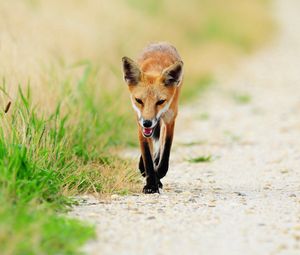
(0, 0, 272, 254)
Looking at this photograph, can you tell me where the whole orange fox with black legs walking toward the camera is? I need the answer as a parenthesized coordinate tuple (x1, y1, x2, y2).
(122, 42, 183, 194)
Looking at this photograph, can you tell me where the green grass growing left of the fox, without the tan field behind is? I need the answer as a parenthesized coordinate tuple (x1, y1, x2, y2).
(0, 78, 138, 254)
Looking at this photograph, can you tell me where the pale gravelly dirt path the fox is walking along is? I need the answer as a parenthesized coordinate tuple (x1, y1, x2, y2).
(72, 0, 300, 255)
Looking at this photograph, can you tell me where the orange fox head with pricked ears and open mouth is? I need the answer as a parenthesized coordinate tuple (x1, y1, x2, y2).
(122, 57, 183, 137)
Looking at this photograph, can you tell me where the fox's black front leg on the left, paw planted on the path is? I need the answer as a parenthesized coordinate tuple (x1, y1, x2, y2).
(143, 142, 159, 194)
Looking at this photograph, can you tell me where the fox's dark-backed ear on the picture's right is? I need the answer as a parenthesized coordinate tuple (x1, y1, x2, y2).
(163, 61, 183, 86)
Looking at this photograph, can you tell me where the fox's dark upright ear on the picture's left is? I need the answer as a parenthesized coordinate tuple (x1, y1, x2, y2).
(122, 57, 141, 85)
